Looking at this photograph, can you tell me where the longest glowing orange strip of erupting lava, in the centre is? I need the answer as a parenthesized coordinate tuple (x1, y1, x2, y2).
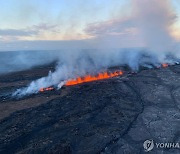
(65, 71, 123, 86)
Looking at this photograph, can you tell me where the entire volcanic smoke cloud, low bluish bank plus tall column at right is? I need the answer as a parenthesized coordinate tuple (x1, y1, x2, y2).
(13, 0, 180, 96)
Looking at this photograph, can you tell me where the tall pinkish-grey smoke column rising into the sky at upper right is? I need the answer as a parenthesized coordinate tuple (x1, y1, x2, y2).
(132, 0, 176, 52)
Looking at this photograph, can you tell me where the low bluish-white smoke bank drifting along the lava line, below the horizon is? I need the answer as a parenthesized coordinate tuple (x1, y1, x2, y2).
(13, 49, 179, 97)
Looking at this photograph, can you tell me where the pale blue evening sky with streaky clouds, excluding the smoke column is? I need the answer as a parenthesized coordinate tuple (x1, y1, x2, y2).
(0, 0, 180, 50)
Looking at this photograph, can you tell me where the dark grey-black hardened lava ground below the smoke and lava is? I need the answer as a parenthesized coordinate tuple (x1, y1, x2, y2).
(0, 65, 180, 154)
